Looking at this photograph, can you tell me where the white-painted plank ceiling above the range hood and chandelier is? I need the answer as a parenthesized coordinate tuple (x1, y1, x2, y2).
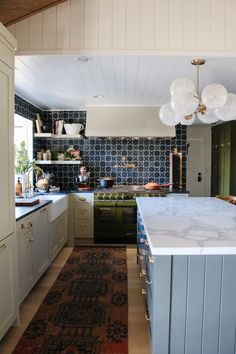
(15, 55, 236, 109)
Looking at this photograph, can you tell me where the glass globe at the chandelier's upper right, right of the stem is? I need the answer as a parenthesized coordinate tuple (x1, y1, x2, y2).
(202, 84, 227, 109)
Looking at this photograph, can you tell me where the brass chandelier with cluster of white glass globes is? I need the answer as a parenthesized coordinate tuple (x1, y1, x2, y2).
(159, 58, 236, 126)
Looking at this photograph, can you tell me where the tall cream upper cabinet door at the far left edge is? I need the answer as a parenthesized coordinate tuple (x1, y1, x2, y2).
(0, 61, 14, 240)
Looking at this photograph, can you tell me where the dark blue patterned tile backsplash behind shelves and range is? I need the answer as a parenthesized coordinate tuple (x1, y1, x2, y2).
(16, 93, 187, 189)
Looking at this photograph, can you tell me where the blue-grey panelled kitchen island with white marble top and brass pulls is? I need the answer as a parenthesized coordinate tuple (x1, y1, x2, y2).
(137, 197, 236, 354)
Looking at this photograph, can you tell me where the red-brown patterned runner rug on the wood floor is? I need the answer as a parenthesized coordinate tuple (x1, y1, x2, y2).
(13, 246, 128, 354)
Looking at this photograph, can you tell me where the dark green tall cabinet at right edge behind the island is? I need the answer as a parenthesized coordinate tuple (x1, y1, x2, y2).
(211, 121, 236, 196)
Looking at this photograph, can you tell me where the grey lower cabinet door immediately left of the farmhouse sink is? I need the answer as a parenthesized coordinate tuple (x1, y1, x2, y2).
(35, 207, 49, 279)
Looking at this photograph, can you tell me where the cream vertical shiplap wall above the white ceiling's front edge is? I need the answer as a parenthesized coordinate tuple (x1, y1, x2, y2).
(5, 0, 236, 55)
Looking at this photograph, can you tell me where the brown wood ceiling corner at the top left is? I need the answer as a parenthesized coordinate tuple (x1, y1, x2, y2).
(0, 0, 66, 26)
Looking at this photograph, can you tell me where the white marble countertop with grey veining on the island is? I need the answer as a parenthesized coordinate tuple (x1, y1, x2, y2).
(136, 197, 236, 255)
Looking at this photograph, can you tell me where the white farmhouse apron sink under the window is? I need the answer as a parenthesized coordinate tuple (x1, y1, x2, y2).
(39, 194, 68, 222)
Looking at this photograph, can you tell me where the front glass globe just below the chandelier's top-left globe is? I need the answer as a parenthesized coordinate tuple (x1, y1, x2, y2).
(171, 93, 199, 116)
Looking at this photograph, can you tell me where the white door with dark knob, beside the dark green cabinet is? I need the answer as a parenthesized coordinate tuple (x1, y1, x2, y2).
(186, 126, 211, 197)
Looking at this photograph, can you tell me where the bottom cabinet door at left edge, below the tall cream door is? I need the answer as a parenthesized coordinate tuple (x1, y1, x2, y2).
(0, 235, 17, 340)
